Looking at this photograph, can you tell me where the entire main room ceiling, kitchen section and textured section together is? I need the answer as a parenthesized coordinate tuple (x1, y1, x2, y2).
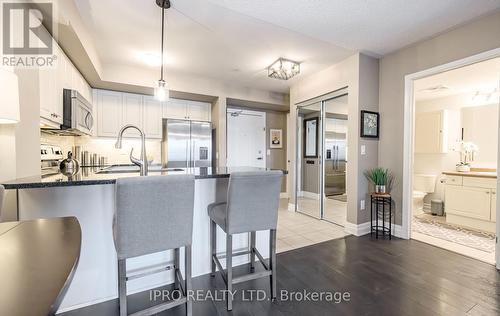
(74, 0, 500, 93)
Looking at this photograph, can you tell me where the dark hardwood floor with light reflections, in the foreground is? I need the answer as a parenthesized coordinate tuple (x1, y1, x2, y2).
(61, 236, 500, 316)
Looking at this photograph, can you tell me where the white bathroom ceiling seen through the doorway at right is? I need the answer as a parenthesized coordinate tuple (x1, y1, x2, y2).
(415, 58, 500, 101)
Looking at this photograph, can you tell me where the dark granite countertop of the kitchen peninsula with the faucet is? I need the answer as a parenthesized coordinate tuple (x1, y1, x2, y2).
(0, 167, 288, 190)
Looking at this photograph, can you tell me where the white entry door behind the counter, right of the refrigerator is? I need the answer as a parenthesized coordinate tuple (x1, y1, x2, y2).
(227, 108, 266, 168)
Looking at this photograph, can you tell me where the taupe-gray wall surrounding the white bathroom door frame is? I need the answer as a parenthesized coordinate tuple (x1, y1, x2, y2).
(378, 11, 500, 224)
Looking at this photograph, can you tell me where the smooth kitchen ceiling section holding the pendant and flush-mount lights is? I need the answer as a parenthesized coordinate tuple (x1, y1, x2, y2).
(75, 0, 353, 93)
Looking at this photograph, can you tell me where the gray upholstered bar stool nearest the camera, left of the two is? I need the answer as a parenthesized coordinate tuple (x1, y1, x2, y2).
(113, 175, 194, 316)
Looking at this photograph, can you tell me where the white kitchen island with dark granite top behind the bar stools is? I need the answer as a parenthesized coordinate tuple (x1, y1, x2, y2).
(2, 168, 286, 312)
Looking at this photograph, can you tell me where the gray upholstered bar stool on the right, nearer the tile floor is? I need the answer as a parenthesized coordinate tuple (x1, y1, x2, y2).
(208, 171, 283, 310)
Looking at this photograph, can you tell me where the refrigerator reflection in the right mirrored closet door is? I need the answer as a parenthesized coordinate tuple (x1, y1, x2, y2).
(325, 118, 347, 196)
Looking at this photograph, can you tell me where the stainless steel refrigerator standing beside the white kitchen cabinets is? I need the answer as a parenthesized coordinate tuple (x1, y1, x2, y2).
(162, 119, 213, 168)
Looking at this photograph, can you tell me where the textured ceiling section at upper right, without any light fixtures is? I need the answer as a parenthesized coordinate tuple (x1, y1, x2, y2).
(208, 0, 500, 55)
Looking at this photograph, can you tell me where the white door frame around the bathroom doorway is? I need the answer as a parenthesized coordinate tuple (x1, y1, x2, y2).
(402, 48, 500, 269)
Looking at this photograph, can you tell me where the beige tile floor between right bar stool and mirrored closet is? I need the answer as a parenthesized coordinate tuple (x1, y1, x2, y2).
(277, 199, 347, 252)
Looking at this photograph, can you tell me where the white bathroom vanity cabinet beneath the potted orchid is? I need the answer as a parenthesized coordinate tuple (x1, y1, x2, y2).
(445, 175, 496, 232)
